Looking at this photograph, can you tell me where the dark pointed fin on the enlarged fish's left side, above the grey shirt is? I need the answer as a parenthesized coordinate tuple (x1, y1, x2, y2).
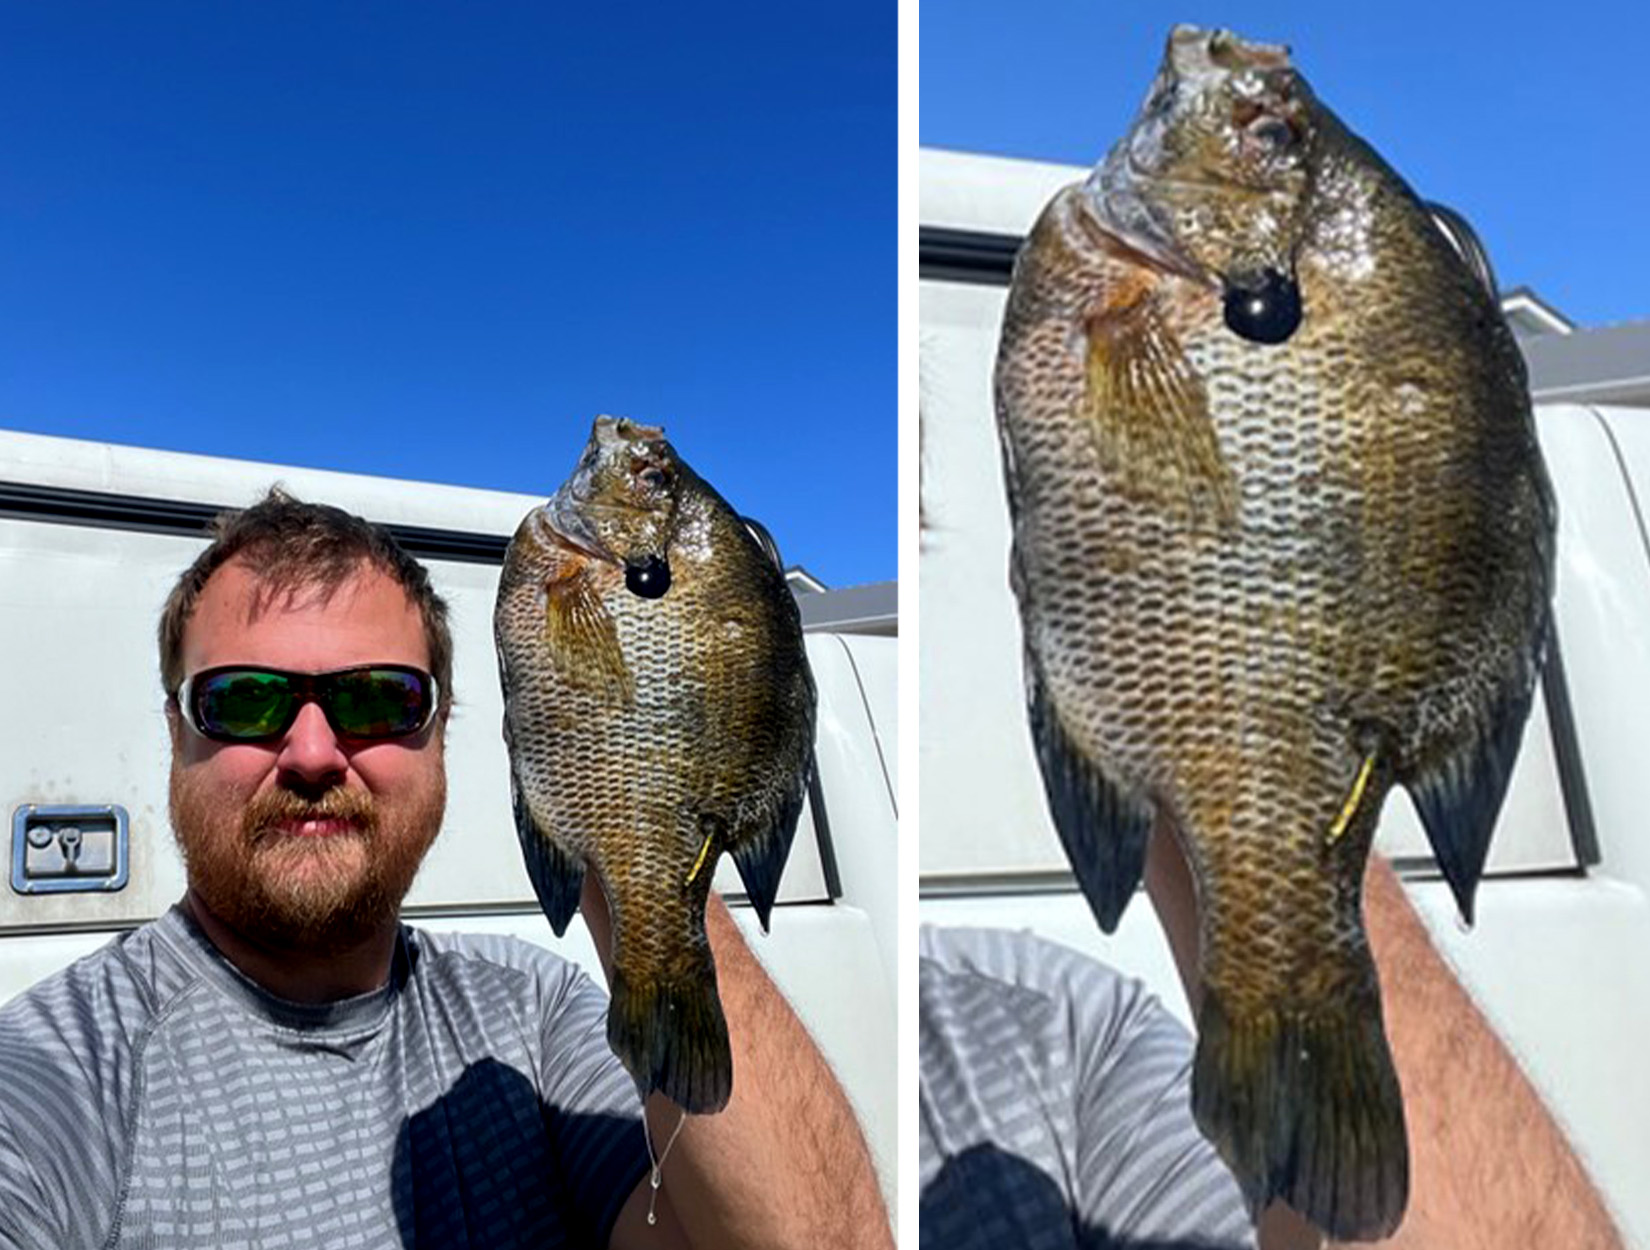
(1026, 651, 1152, 933)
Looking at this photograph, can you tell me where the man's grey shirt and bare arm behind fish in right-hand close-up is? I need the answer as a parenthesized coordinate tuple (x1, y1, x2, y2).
(919, 828, 1622, 1250)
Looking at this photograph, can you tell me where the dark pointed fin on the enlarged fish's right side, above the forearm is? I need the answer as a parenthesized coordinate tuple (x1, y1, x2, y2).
(1403, 632, 1544, 925)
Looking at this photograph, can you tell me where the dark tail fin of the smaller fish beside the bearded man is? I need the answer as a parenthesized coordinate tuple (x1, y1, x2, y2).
(607, 952, 733, 1115)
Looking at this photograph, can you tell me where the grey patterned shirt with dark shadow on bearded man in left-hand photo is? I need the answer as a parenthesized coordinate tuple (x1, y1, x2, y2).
(0, 909, 647, 1250)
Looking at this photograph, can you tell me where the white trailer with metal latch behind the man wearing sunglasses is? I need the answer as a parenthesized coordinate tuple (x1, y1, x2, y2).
(0, 425, 898, 1202)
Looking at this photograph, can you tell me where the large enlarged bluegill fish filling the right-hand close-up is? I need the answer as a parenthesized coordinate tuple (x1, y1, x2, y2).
(995, 26, 1554, 1240)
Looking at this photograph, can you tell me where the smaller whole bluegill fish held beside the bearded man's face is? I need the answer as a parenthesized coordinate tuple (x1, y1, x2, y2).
(493, 417, 815, 1111)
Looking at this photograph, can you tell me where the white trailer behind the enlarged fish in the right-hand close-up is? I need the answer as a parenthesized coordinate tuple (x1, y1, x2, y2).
(917, 150, 1650, 1250)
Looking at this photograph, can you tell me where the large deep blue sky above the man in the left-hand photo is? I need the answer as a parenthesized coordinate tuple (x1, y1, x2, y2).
(0, 0, 898, 585)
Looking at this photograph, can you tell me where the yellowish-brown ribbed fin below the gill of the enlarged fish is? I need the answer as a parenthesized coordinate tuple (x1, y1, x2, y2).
(1084, 270, 1238, 526)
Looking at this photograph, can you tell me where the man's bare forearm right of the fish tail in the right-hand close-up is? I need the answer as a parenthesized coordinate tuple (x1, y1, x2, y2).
(1365, 861, 1622, 1250)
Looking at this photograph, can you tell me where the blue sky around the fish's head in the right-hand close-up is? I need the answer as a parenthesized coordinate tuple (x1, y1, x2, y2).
(919, 0, 1650, 325)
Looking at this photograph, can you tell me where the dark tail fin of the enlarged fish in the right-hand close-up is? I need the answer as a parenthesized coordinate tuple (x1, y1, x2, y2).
(1191, 988, 1409, 1242)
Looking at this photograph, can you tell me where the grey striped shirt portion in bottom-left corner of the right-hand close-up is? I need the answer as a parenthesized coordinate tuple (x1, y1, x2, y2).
(917, 928, 1254, 1250)
